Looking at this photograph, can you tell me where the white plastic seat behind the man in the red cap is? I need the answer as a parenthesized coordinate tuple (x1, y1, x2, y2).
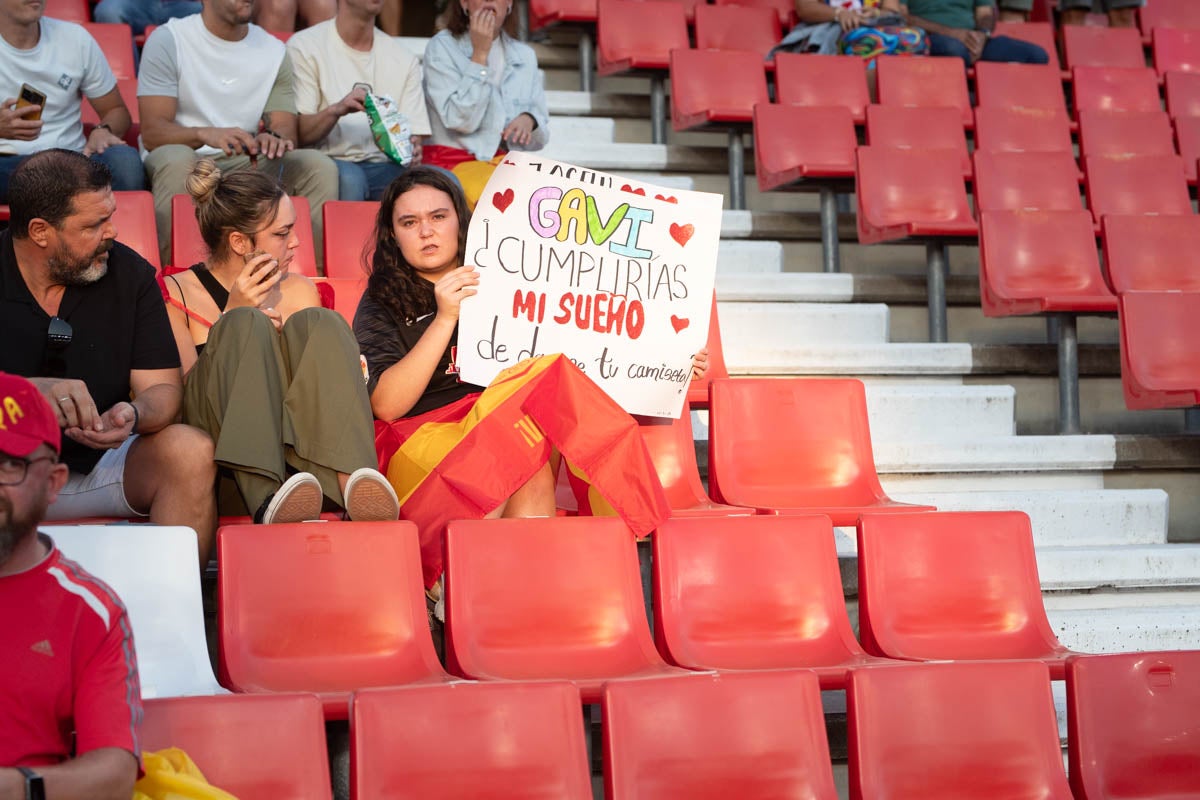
(42, 524, 224, 698)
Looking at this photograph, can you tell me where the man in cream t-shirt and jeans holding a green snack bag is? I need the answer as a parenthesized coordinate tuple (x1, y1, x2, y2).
(288, 0, 430, 200)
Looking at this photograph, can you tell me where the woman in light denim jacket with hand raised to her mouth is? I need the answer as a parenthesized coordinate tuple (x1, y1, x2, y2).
(422, 0, 550, 209)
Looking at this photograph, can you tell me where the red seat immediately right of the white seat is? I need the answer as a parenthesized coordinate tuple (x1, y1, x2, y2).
(217, 522, 450, 720)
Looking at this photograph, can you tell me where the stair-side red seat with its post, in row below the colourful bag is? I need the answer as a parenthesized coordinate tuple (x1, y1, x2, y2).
(671, 49, 770, 209)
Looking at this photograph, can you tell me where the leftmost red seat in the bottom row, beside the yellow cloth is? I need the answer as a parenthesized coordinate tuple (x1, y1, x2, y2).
(138, 695, 332, 800)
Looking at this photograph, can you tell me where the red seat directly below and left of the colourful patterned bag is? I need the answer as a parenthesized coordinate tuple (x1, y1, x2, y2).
(775, 53, 871, 125)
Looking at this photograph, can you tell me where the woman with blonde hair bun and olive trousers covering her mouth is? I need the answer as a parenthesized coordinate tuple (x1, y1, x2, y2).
(166, 158, 400, 523)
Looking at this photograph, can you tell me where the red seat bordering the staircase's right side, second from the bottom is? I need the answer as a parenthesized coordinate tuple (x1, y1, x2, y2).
(979, 210, 1117, 317)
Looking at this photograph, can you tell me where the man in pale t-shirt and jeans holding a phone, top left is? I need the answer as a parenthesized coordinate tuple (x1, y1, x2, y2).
(0, 0, 145, 203)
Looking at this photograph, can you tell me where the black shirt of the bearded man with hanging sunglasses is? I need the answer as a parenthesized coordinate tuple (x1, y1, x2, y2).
(0, 231, 179, 473)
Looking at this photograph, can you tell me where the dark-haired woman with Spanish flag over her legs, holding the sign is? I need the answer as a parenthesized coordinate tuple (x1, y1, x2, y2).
(354, 167, 668, 587)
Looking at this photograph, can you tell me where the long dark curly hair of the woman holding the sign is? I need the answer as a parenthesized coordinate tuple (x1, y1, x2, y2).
(366, 167, 470, 324)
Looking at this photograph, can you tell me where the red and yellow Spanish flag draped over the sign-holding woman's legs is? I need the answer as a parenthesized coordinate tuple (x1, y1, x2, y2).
(376, 355, 671, 587)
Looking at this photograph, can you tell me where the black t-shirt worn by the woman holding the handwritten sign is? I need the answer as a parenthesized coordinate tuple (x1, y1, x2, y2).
(354, 294, 482, 416)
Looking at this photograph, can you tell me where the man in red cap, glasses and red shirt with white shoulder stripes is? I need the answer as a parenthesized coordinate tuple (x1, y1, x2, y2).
(0, 373, 142, 800)
